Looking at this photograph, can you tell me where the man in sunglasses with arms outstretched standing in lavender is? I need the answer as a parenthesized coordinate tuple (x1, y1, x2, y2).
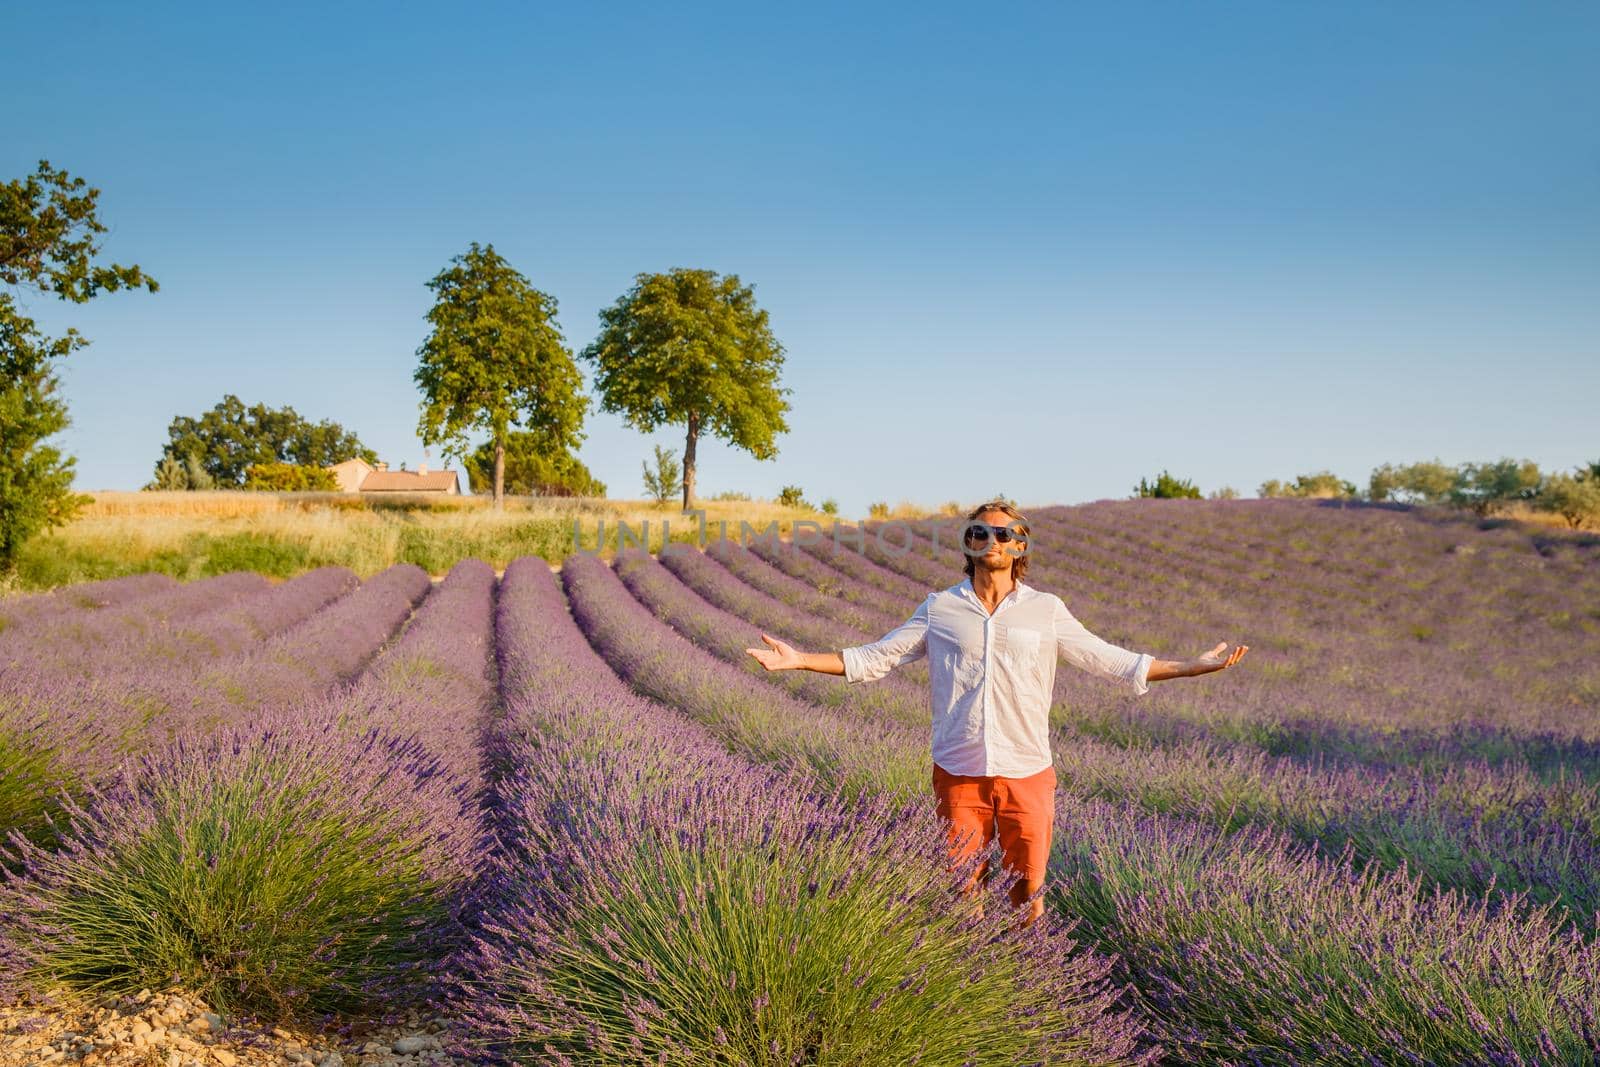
(746, 501, 1250, 923)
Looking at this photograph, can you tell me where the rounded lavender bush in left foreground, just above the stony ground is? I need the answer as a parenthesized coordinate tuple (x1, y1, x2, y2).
(0, 717, 475, 1017)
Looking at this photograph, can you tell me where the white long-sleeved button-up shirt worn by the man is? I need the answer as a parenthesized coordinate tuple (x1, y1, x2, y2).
(842, 577, 1155, 777)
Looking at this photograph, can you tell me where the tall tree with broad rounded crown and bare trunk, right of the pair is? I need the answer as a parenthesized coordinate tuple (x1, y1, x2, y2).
(582, 267, 790, 510)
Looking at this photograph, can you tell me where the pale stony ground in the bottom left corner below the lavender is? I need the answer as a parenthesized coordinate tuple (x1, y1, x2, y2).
(0, 990, 467, 1067)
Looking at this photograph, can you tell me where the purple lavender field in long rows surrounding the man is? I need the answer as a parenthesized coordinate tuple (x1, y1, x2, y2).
(0, 501, 1600, 1067)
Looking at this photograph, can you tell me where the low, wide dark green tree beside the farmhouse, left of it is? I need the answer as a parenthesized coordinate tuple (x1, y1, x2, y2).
(155, 394, 378, 490)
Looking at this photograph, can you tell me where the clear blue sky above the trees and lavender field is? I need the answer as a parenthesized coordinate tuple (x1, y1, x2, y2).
(0, 2, 1600, 515)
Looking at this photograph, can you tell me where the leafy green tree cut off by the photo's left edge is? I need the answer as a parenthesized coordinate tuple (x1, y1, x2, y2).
(0, 160, 160, 576)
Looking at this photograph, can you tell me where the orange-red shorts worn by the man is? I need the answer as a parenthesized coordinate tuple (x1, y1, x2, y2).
(933, 763, 1056, 899)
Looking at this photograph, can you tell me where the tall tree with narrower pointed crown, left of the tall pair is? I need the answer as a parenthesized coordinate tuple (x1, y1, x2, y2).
(414, 242, 589, 509)
